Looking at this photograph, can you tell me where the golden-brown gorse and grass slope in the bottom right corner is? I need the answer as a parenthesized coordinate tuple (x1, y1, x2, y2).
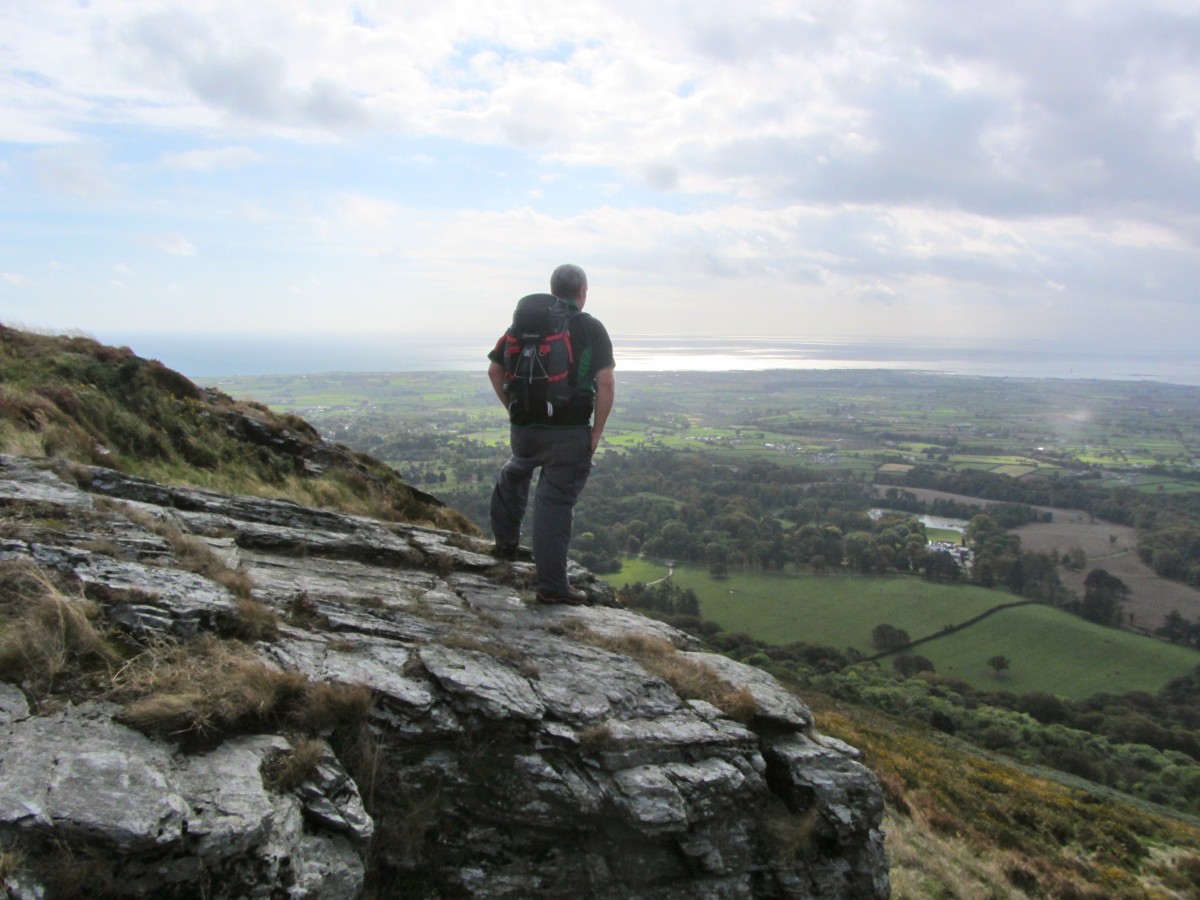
(805, 690, 1200, 900)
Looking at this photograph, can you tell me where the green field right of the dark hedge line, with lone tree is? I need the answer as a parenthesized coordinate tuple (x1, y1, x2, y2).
(916, 606, 1200, 698)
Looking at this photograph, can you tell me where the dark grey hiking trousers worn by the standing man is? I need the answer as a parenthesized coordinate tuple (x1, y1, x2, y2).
(491, 425, 592, 594)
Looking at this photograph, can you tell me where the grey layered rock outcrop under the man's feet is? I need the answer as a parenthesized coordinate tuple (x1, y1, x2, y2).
(0, 457, 888, 900)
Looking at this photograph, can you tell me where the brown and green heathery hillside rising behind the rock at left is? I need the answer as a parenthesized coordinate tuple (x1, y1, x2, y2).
(0, 324, 475, 533)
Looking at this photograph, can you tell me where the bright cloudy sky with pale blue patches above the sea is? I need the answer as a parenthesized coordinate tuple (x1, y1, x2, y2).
(0, 0, 1200, 362)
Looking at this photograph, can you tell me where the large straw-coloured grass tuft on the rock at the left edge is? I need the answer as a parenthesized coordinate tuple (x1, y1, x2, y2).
(0, 560, 118, 697)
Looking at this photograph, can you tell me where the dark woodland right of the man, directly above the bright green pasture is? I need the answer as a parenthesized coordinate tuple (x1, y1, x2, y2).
(577, 449, 1063, 601)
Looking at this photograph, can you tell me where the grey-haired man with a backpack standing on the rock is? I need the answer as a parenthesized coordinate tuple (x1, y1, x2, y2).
(487, 264, 616, 605)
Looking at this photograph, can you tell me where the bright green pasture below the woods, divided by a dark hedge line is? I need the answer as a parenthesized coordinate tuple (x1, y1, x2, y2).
(607, 559, 1200, 700)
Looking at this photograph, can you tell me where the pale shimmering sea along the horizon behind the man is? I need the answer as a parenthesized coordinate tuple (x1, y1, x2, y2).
(96, 332, 1200, 386)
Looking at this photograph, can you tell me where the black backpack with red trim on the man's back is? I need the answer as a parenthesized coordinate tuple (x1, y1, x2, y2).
(500, 294, 578, 425)
